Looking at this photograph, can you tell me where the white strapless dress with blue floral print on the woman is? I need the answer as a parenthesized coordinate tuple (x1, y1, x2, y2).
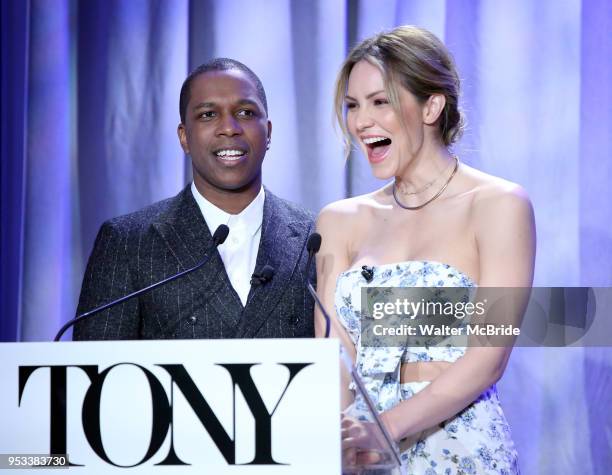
(335, 261, 519, 475)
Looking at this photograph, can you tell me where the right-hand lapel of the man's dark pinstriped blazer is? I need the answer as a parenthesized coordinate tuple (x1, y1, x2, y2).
(236, 189, 307, 338)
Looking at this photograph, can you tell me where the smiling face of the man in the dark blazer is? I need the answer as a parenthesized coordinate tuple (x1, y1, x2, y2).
(178, 69, 272, 193)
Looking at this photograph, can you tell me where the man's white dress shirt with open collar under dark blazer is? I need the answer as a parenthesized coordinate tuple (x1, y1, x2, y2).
(191, 182, 266, 306)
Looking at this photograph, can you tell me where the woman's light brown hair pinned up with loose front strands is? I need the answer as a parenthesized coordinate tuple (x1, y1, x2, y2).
(334, 25, 465, 156)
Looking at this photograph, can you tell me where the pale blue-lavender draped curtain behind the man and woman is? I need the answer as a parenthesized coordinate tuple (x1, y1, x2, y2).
(0, 0, 612, 474)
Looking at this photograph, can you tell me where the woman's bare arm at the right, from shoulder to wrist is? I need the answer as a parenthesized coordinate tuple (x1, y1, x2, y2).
(382, 187, 535, 441)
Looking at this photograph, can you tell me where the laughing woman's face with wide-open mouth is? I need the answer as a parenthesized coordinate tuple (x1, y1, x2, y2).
(346, 60, 424, 179)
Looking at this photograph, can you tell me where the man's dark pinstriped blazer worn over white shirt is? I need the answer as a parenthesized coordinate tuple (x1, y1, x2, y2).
(73, 187, 314, 340)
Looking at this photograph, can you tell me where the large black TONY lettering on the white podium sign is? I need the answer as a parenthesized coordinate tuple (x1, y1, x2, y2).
(19, 363, 312, 468)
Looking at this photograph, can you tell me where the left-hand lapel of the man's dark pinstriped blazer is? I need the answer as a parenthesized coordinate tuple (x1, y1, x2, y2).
(153, 187, 242, 330)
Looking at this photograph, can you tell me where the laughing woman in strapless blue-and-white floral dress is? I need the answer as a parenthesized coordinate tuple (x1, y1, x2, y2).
(315, 26, 535, 474)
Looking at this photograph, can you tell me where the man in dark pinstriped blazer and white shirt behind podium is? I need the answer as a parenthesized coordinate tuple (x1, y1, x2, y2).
(74, 58, 314, 340)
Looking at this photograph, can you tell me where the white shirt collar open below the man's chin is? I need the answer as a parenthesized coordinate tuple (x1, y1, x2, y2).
(191, 182, 266, 236)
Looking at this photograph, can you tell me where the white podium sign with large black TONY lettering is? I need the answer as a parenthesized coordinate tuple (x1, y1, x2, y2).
(0, 339, 341, 475)
